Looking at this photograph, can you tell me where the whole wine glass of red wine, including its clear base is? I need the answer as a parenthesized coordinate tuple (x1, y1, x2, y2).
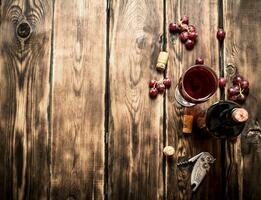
(175, 65, 218, 107)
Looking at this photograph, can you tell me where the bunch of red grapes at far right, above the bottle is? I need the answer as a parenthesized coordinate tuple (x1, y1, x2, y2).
(227, 75, 249, 103)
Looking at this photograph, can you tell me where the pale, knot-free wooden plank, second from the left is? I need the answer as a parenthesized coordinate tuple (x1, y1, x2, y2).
(51, 0, 106, 200)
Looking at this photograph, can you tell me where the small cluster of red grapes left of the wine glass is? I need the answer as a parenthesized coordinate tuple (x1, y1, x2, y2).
(149, 78, 171, 98)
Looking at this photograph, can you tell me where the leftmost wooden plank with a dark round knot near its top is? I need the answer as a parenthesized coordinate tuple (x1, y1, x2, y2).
(0, 0, 52, 200)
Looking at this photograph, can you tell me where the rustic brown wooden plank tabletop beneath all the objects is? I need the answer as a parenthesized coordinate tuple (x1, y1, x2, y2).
(0, 0, 261, 200)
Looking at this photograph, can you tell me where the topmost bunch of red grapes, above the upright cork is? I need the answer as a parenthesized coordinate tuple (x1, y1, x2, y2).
(169, 15, 198, 50)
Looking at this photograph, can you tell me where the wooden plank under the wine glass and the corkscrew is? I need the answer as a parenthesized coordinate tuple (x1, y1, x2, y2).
(166, 0, 222, 200)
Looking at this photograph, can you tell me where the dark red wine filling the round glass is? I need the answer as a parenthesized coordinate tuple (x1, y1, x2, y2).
(183, 66, 217, 99)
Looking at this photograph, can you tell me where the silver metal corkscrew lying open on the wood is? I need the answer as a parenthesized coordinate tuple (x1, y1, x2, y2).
(177, 152, 216, 192)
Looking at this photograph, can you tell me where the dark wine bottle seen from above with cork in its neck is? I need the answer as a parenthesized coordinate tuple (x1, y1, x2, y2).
(206, 101, 248, 138)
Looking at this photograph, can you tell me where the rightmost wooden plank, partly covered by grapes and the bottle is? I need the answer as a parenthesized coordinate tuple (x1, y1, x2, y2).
(224, 0, 261, 200)
